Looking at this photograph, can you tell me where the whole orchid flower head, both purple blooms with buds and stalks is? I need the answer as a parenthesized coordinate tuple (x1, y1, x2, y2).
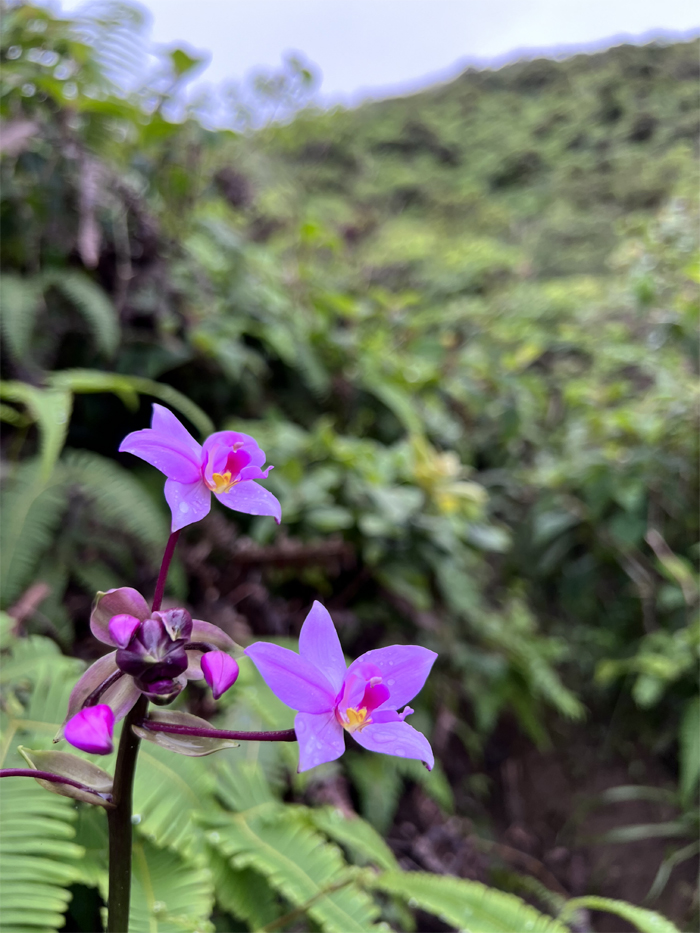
(57, 405, 437, 771)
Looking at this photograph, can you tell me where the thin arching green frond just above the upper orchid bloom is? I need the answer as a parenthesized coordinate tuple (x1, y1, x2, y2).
(49, 369, 214, 435)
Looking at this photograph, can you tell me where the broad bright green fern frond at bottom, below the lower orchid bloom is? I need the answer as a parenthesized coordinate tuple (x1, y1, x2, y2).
(203, 803, 379, 933)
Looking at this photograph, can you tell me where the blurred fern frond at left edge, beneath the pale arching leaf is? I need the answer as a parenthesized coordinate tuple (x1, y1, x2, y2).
(0, 461, 66, 605)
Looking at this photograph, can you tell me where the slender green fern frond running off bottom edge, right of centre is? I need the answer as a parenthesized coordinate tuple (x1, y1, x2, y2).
(370, 871, 569, 933)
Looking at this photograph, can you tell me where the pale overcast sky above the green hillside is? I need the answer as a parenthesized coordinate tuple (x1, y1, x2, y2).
(45, 0, 700, 103)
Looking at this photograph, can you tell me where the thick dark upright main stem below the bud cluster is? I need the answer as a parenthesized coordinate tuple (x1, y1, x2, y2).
(107, 696, 148, 933)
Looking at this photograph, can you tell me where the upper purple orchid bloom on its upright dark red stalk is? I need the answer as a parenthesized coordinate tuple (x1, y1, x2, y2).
(119, 405, 282, 531)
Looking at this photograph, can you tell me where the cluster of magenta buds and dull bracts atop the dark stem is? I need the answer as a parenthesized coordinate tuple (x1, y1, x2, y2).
(54, 586, 240, 754)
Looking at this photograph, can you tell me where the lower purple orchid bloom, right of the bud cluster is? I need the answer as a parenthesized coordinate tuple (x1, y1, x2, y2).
(245, 602, 437, 771)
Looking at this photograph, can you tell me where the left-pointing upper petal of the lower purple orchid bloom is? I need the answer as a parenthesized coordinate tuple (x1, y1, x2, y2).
(245, 641, 335, 713)
